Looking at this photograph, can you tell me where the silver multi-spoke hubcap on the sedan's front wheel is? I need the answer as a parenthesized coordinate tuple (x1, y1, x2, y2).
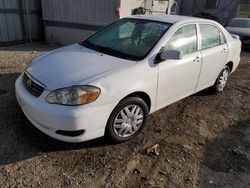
(113, 105, 144, 137)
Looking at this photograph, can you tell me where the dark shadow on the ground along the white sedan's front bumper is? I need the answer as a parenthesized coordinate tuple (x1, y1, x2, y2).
(0, 73, 115, 166)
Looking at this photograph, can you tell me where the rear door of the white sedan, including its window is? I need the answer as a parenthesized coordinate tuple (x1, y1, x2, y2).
(197, 24, 228, 90)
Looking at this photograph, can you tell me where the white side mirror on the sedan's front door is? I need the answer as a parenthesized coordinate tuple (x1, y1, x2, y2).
(155, 50, 182, 64)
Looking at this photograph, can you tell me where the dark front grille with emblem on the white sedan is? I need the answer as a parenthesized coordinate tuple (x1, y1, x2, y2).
(23, 73, 44, 97)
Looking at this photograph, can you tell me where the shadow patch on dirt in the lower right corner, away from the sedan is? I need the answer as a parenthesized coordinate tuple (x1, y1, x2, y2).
(197, 119, 250, 188)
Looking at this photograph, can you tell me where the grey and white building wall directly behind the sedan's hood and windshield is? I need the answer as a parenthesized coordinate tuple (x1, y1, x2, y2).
(42, 0, 179, 45)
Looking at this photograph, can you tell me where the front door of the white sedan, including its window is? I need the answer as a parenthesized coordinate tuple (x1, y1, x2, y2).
(157, 24, 201, 109)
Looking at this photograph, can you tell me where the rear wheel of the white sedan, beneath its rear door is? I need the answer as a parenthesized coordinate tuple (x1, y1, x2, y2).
(212, 66, 230, 93)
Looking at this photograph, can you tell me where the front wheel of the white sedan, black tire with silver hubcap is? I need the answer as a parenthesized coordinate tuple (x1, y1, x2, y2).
(105, 97, 149, 143)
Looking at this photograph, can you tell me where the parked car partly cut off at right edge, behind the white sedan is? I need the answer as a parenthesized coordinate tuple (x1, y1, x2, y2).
(226, 18, 250, 48)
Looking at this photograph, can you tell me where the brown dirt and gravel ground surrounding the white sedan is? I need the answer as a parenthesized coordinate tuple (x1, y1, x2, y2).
(0, 44, 250, 188)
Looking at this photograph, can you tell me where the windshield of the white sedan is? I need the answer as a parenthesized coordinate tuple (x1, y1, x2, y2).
(79, 18, 171, 60)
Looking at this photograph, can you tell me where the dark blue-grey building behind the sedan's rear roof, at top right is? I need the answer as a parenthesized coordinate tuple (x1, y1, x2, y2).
(180, 0, 250, 25)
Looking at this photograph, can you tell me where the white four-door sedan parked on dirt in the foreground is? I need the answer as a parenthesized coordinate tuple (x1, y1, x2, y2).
(15, 16, 241, 142)
